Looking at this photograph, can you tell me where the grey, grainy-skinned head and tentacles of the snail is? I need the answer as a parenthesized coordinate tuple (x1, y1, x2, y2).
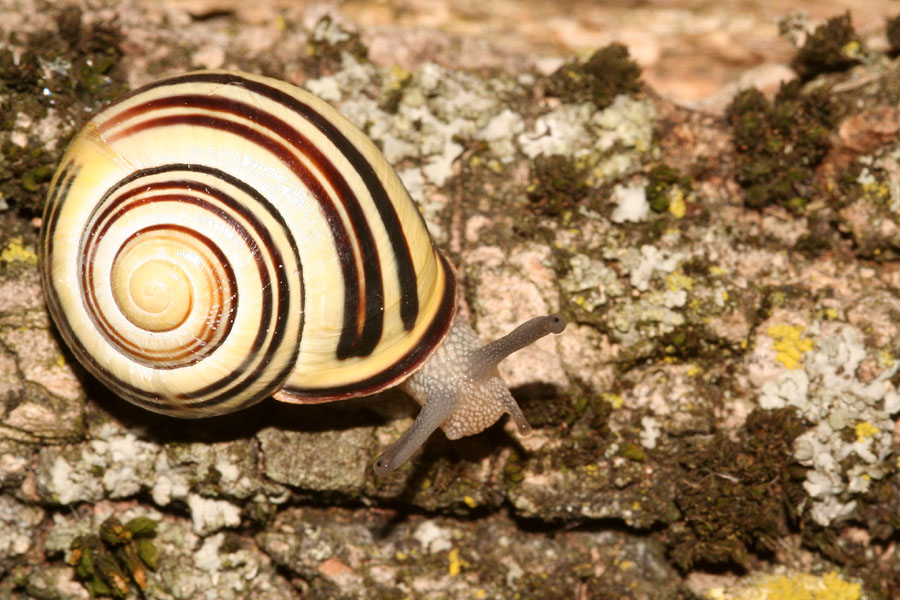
(375, 314, 566, 477)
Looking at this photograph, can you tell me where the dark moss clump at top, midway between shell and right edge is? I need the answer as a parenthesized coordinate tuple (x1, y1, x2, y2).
(546, 44, 641, 109)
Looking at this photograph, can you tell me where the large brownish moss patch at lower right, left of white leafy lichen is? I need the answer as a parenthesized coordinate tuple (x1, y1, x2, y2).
(664, 409, 805, 570)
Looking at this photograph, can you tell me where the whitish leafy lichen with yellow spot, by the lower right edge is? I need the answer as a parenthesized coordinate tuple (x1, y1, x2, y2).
(759, 325, 900, 526)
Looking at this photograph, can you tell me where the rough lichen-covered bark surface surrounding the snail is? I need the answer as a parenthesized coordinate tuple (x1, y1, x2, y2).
(0, 0, 900, 599)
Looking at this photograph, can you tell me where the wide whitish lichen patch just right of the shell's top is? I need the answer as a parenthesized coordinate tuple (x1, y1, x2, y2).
(304, 54, 657, 193)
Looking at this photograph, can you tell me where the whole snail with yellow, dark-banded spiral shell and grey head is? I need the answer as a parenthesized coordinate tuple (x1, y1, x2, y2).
(39, 71, 566, 476)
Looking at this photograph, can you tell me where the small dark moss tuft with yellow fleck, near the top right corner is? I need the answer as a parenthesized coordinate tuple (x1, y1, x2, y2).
(792, 11, 863, 80)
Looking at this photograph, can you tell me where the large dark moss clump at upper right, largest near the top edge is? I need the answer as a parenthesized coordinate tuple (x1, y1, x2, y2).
(727, 81, 838, 213)
